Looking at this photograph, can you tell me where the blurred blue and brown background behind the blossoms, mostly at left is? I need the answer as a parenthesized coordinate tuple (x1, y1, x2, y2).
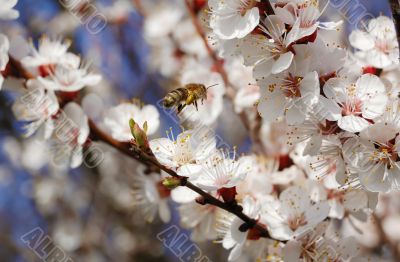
(0, 0, 390, 261)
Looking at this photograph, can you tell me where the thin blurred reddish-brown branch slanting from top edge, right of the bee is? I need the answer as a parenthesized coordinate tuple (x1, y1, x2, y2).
(185, 0, 266, 154)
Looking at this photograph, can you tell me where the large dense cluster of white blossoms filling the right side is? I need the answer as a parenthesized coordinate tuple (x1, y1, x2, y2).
(137, 0, 400, 261)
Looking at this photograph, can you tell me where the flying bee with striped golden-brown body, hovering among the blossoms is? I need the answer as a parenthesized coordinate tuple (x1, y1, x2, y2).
(163, 83, 216, 114)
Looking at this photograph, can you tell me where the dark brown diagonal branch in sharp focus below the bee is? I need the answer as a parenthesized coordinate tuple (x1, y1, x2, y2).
(89, 120, 271, 238)
